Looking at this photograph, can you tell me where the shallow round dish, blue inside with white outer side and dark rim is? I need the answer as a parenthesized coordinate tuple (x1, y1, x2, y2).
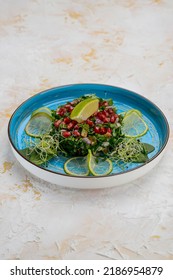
(8, 84, 169, 187)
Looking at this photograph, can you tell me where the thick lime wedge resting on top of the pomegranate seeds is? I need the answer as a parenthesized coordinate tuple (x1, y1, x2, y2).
(70, 98, 99, 123)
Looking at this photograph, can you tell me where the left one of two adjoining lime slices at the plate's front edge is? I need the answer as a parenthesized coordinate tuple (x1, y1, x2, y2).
(64, 157, 89, 176)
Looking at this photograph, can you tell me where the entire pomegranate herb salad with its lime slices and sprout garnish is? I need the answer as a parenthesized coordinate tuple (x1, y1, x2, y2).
(20, 94, 154, 176)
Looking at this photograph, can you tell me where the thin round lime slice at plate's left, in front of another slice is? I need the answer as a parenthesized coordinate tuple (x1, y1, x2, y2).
(25, 113, 52, 137)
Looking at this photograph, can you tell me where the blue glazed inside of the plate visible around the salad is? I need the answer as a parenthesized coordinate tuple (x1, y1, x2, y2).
(9, 84, 169, 175)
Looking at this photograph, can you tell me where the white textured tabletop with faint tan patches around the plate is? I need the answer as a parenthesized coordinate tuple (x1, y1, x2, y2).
(0, 0, 173, 259)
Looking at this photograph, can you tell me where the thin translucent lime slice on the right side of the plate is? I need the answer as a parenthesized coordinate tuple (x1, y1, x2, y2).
(122, 110, 148, 137)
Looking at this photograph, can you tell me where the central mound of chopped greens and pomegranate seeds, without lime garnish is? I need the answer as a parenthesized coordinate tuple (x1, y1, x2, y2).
(52, 96, 122, 156)
